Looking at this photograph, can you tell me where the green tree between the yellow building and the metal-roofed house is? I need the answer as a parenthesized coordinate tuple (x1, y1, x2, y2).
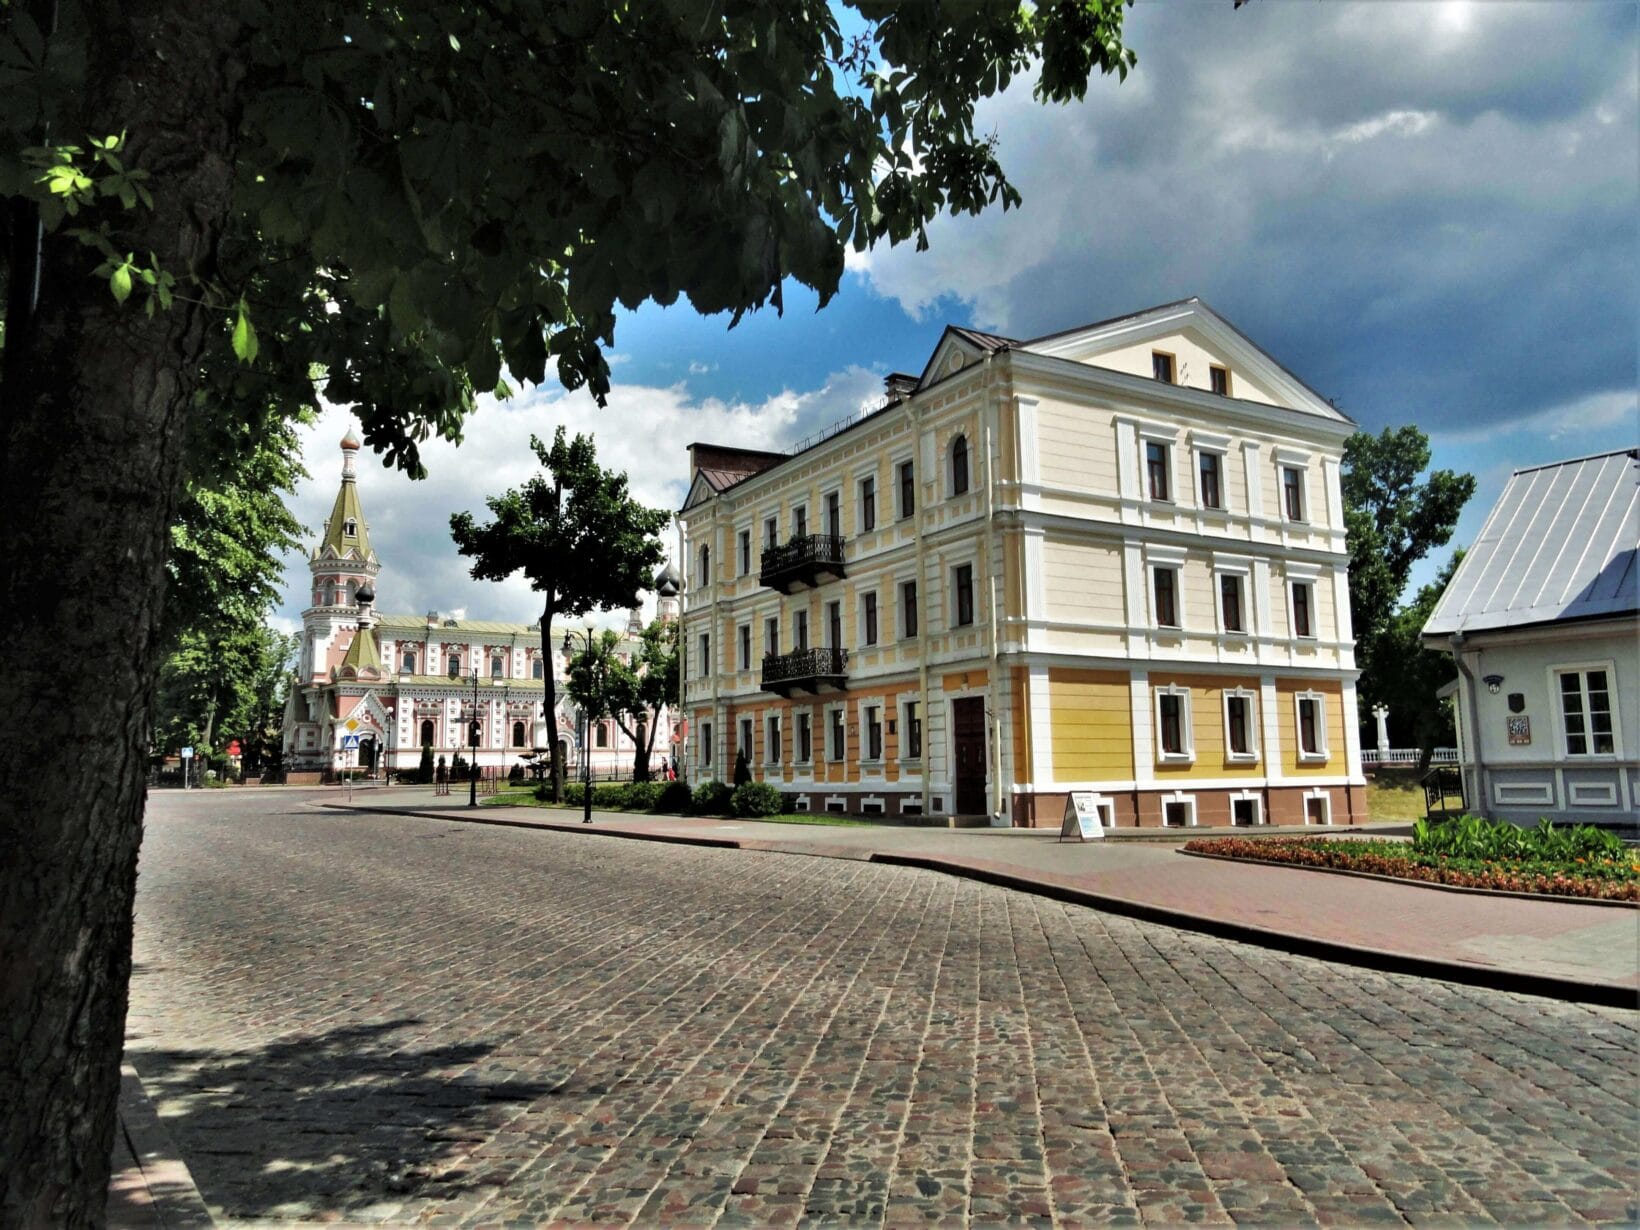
(1342, 425, 1474, 713)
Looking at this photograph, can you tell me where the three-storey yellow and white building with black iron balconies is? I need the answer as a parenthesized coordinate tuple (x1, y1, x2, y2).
(681, 298, 1366, 827)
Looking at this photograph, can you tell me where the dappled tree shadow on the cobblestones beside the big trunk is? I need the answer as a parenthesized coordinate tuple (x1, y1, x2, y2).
(126, 1018, 548, 1219)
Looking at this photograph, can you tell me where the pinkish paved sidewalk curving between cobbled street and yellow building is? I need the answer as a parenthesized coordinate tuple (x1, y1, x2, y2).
(321, 787, 1640, 1007)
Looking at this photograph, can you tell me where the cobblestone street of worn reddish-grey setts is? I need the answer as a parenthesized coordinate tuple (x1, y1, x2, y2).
(126, 794, 1640, 1225)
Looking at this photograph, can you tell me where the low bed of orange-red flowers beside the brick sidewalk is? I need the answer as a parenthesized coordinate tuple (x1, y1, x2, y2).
(1184, 836, 1640, 902)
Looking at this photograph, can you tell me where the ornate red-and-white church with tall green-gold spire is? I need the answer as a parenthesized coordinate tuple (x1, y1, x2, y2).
(284, 428, 679, 784)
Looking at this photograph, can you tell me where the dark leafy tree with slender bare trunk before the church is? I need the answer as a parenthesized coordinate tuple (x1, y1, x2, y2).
(449, 426, 672, 802)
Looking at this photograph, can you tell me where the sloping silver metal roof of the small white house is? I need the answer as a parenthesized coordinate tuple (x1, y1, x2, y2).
(1424, 449, 1640, 636)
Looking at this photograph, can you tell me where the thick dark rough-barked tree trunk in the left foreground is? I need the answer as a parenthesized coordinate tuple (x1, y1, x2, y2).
(0, 0, 243, 1227)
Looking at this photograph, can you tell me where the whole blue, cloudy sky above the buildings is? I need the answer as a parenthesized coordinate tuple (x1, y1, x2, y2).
(274, 0, 1640, 631)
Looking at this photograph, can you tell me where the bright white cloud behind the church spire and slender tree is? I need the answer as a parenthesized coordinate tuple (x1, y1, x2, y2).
(272, 367, 882, 628)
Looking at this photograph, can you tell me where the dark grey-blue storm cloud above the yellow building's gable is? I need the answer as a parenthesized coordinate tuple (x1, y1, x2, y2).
(868, 3, 1640, 439)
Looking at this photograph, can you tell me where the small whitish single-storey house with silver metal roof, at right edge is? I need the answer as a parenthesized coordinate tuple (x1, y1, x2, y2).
(1424, 448, 1640, 823)
